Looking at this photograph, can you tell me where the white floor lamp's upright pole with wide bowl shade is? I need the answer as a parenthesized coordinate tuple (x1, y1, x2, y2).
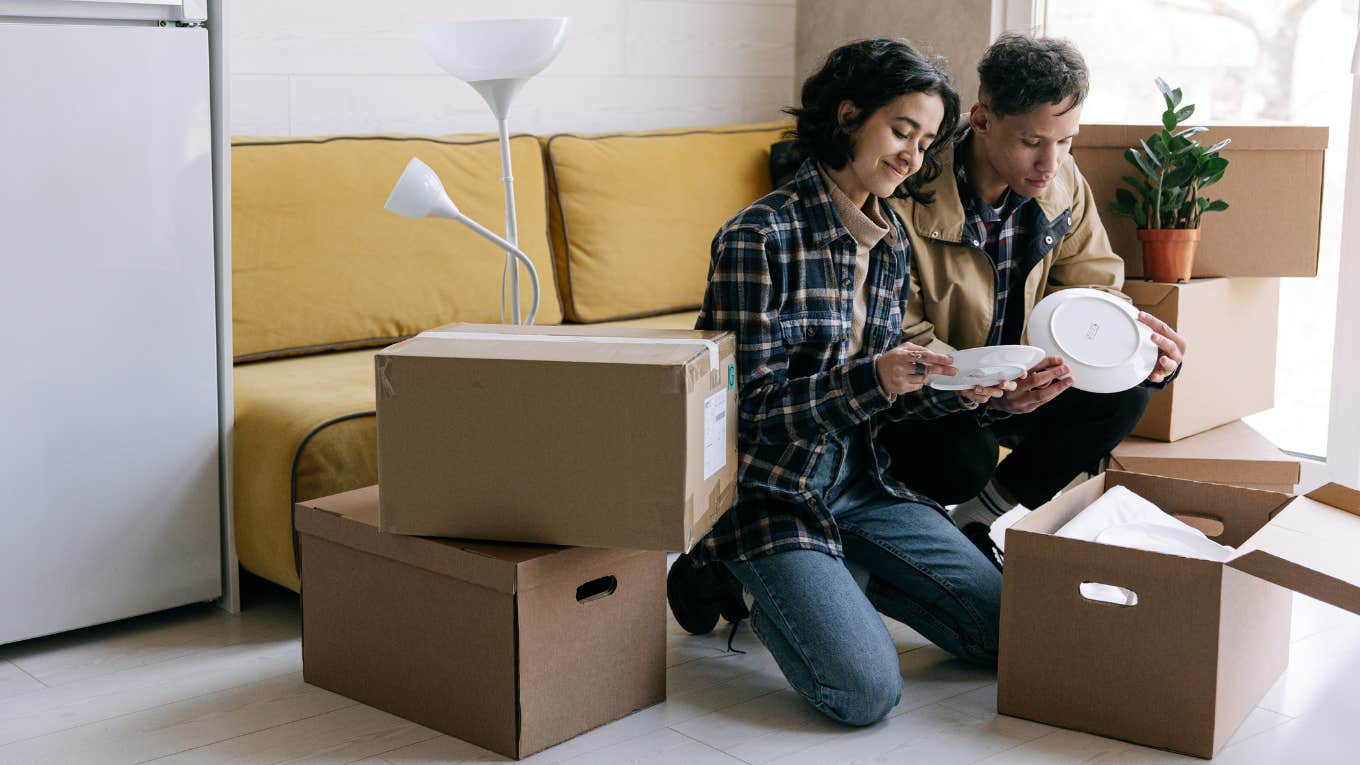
(424, 18, 570, 324)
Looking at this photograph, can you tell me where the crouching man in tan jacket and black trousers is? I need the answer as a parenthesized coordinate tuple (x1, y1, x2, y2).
(879, 34, 1186, 568)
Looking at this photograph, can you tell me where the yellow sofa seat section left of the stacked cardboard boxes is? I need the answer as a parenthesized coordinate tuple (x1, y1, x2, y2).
(233, 348, 378, 589)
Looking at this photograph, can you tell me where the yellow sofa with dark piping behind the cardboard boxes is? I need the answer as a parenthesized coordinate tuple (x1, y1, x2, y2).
(231, 123, 787, 589)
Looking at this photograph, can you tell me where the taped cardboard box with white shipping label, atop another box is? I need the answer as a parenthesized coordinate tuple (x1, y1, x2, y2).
(375, 324, 737, 550)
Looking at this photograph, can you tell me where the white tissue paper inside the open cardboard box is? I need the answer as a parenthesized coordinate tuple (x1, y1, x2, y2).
(1057, 486, 1234, 606)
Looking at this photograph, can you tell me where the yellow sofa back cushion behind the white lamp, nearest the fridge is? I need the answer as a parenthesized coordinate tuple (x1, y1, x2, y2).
(231, 136, 562, 361)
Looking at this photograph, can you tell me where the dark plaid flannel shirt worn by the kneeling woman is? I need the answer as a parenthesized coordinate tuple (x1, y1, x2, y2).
(695, 161, 975, 559)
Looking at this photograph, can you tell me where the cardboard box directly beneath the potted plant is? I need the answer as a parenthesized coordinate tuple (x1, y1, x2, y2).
(1123, 279, 1280, 441)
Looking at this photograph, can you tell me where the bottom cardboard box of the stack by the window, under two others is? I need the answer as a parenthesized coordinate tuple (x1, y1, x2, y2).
(1110, 421, 1300, 494)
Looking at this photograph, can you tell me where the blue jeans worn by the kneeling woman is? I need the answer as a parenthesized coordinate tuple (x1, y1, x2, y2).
(726, 429, 1001, 726)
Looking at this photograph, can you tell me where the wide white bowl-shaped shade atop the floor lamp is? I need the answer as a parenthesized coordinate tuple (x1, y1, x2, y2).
(424, 18, 568, 83)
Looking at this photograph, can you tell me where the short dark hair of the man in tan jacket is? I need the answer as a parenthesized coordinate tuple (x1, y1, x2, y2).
(978, 33, 1091, 117)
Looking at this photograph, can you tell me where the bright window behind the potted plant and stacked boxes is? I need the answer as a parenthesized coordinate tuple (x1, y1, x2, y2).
(1039, 0, 1360, 456)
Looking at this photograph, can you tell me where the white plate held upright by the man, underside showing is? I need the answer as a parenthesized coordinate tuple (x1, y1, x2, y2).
(1028, 287, 1157, 393)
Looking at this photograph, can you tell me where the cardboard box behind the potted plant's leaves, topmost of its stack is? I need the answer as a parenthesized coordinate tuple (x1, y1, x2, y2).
(1072, 125, 1327, 276)
